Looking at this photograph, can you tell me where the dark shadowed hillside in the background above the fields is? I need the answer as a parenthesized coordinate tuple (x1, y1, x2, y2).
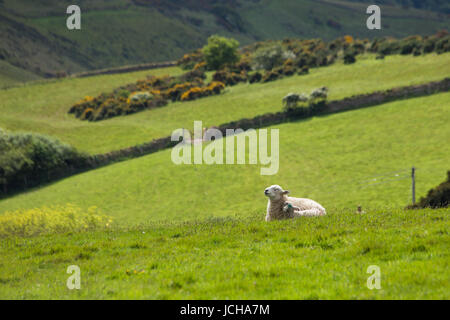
(0, 0, 449, 84)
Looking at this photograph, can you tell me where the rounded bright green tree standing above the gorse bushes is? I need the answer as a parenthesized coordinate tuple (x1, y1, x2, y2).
(203, 35, 240, 70)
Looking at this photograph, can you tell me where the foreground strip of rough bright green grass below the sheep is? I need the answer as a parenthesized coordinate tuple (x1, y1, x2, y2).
(0, 209, 450, 299)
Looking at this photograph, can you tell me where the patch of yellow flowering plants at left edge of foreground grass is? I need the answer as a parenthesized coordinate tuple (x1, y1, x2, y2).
(0, 204, 112, 238)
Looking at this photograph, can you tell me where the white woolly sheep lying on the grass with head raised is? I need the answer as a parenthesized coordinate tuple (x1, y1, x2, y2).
(264, 185, 326, 221)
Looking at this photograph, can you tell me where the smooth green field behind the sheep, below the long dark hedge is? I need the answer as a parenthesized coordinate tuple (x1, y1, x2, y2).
(0, 93, 450, 225)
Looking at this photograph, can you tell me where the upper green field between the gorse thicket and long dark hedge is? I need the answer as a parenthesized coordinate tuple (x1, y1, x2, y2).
(0, 54, 450, 153)
